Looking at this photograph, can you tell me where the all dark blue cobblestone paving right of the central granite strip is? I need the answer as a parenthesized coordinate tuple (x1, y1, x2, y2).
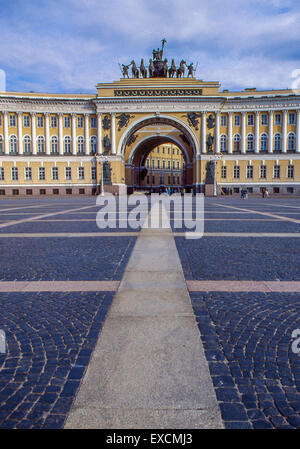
(176, 199, 300, 429)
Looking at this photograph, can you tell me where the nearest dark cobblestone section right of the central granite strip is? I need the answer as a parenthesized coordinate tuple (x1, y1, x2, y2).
(191, 293, 300, 429)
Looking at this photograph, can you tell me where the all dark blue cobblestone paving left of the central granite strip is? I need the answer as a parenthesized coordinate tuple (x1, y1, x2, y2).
(0, 199, 136, 429)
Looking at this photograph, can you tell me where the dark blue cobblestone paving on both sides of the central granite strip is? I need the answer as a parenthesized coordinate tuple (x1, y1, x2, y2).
(0, 198, 300, 428)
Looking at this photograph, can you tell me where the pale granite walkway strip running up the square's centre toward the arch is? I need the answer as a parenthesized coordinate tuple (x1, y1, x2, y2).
(65, 202, 224, 429)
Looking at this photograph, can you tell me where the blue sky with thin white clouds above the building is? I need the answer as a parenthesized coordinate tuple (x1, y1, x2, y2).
(0, 0, 300, 94)
